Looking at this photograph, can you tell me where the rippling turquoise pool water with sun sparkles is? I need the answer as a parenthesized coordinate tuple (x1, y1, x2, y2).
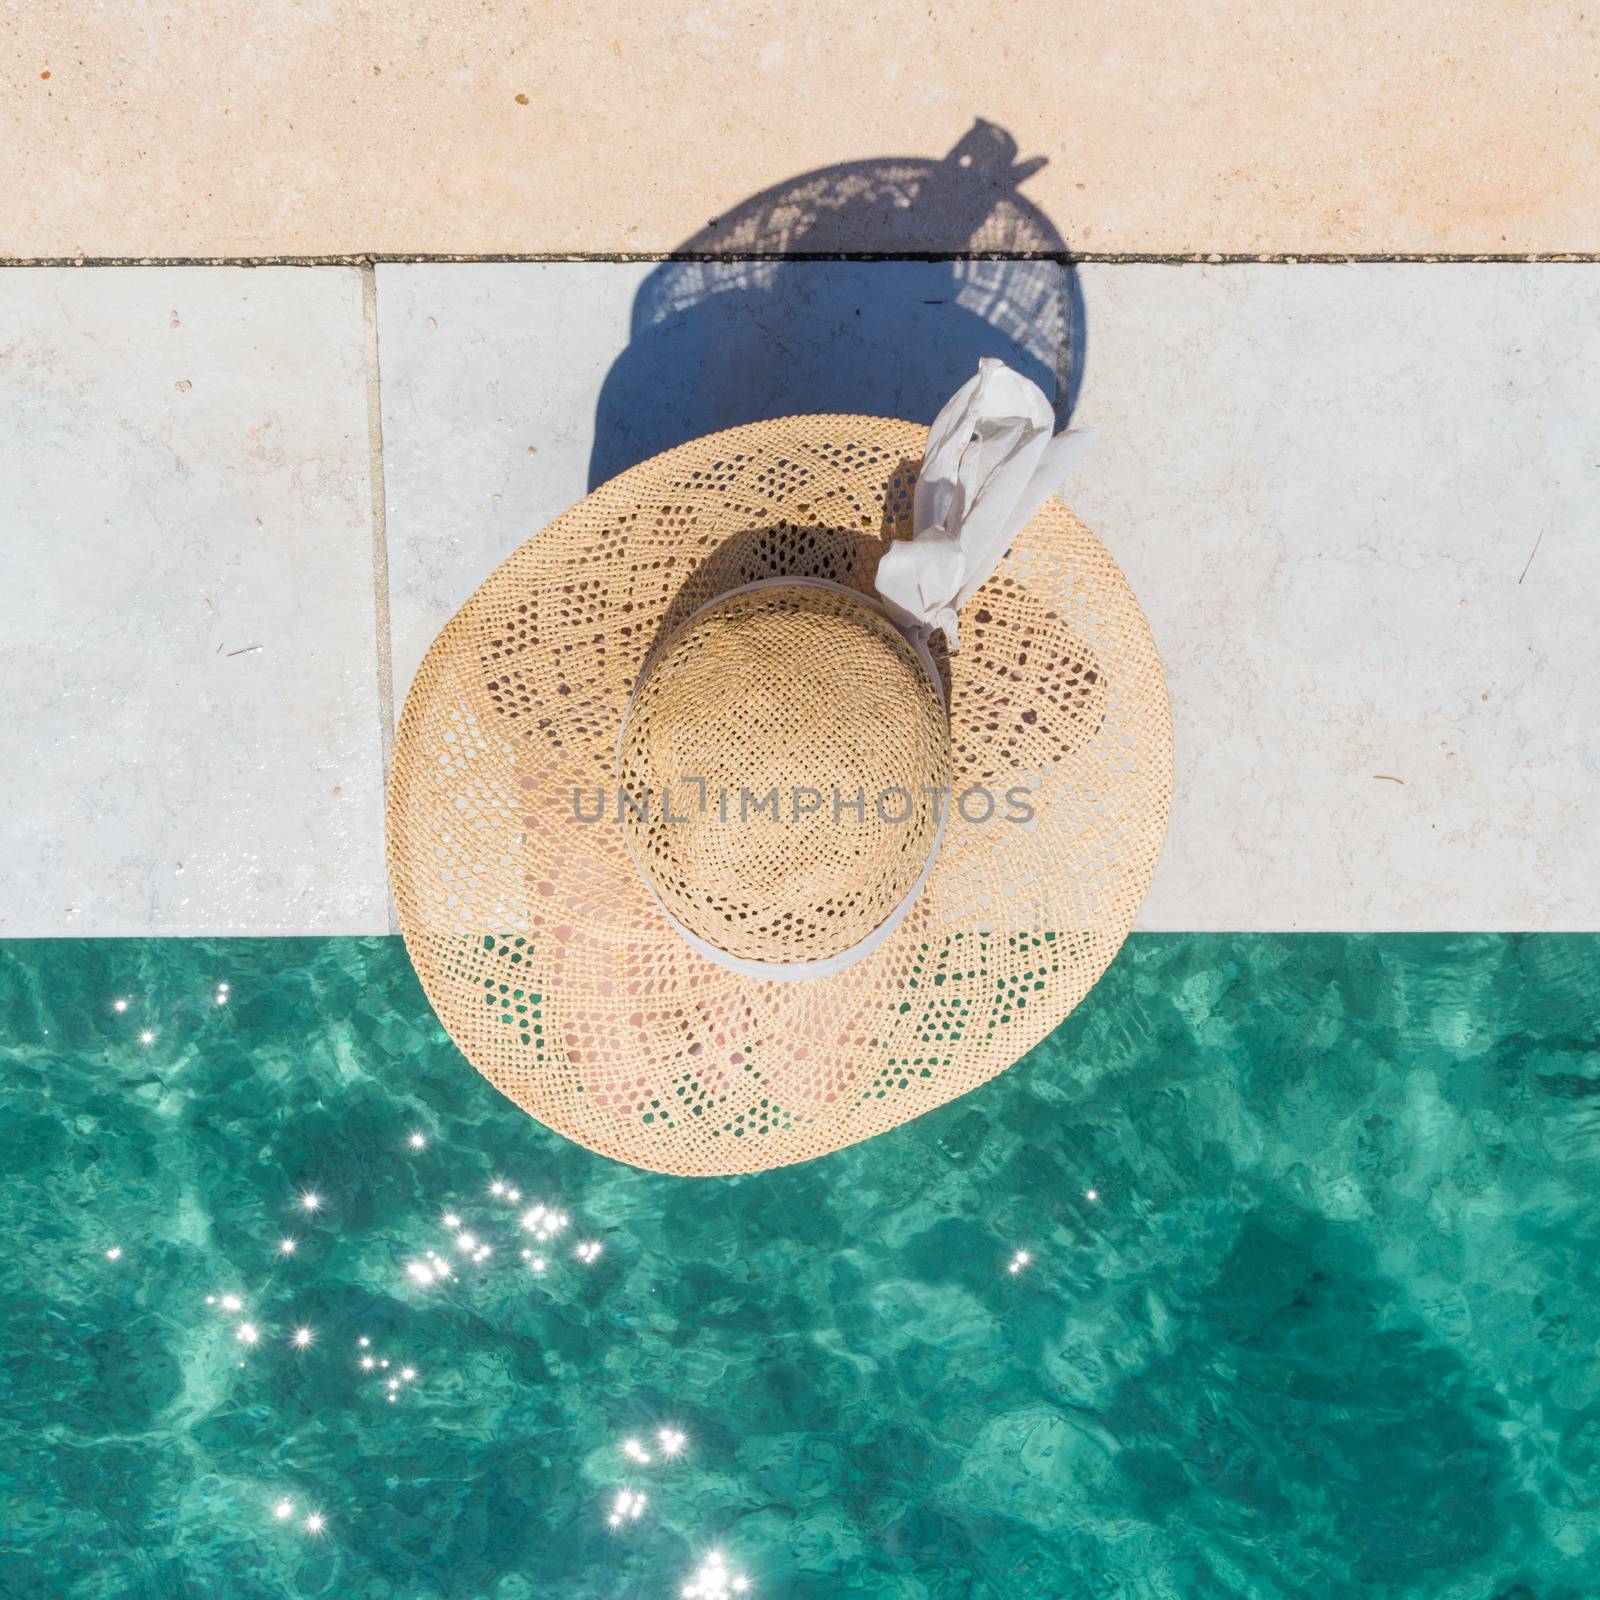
(0, 936, 1600, 1600)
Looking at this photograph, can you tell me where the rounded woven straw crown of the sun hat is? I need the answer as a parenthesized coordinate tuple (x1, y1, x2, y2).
(618, 586, 950, 962)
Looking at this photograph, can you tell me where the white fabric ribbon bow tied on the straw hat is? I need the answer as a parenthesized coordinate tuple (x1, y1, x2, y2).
(877, 357, 1094, 653)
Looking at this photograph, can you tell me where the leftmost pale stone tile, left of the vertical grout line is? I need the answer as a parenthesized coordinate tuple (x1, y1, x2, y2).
(0, 267, 387, 936)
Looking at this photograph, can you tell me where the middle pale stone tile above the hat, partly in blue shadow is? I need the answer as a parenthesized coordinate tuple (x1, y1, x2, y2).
(378, 261, 1064, 709)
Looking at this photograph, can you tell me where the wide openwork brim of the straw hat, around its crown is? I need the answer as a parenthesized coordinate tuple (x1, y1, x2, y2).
(387, 416, 1171, 1174)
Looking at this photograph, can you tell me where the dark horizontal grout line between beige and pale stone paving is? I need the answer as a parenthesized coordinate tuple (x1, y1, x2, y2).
(0, 250, 1600, 267)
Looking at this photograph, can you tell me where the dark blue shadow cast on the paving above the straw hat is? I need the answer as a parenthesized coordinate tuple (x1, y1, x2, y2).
(589, 122, 1085, 488)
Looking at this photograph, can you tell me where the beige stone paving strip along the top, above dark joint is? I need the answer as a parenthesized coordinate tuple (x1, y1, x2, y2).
(0, 0, 1600, 259)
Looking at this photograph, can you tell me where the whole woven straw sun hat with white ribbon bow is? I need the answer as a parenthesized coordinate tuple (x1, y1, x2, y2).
(387, 362, 1171, 1174)
